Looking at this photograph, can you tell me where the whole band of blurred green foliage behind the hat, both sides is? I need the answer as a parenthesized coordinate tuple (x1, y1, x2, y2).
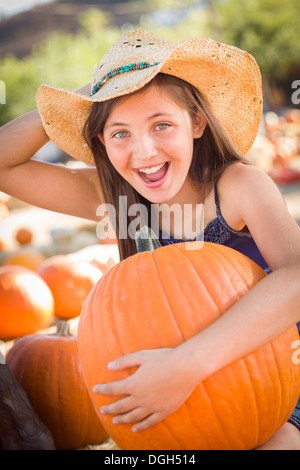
(0, 0, 300, 125)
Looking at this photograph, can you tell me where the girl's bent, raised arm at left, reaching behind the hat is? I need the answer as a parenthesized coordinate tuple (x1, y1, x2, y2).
(0, 83, 103, 220)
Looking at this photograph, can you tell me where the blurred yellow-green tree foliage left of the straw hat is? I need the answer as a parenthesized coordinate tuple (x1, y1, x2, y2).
(0, 9, 120, 125)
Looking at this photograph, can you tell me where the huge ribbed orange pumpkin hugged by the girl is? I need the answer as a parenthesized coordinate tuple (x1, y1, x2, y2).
(78, 242, 300, 450)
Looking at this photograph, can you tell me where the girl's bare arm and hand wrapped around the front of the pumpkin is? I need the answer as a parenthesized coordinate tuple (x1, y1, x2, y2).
(95, 164, 300, 431)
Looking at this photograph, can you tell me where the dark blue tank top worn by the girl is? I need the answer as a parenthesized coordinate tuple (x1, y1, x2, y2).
(135, 183, 300, 333)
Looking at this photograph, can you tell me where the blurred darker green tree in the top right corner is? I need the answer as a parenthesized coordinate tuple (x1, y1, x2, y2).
(217, 0, 300, 106)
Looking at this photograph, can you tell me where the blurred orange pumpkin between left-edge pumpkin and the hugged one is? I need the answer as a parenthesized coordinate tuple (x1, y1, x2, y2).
(37, 255, 102, 319)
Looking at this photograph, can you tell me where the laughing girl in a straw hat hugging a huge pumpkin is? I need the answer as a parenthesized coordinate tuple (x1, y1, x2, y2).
(0, 32, 300, 449)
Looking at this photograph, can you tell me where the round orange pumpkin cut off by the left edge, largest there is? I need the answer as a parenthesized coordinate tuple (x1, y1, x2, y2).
(0, 266, 54, 340)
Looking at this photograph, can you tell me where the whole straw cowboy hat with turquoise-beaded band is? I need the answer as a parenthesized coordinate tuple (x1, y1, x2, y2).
(36, 31, 262, 165)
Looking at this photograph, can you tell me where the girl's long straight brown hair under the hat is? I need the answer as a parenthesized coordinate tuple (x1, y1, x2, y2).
(83, 73, 247, 260)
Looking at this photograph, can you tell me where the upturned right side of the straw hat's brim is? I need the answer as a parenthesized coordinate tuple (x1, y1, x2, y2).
(161, 38, 263, 155)
